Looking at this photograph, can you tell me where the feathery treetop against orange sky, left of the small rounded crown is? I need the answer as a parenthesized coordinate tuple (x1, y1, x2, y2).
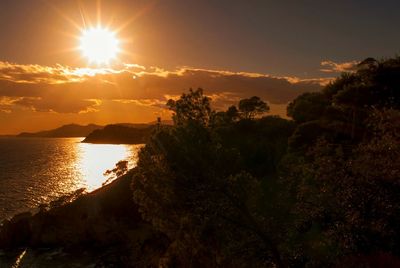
(167, 88, 212, 126)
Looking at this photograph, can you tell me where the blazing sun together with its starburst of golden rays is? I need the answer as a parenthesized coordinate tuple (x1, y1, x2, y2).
(46, 0, 148, 68)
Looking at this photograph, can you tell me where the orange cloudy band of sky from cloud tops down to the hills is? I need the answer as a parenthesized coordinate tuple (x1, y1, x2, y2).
(0, 62, 326, 134)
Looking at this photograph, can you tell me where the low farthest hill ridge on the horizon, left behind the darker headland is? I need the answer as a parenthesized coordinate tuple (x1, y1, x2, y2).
(17, 124, 103, 138)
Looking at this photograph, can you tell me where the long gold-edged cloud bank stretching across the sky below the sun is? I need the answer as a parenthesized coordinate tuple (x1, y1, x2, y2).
(0, 62, 331, 114)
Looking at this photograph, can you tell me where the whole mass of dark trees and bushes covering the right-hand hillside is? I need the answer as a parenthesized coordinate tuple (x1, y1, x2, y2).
(132, 58, 400, 267)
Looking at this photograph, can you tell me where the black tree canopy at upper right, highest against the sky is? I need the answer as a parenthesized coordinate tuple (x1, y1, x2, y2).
(287, 57, 400, 143)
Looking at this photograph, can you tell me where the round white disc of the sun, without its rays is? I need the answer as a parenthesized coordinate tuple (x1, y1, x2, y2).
(79, 27, 120, 65)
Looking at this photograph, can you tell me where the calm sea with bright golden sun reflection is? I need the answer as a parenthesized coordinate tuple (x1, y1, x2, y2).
(0, 138, 142, 221)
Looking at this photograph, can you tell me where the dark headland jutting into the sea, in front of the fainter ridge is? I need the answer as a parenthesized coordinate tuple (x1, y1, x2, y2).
(82, 124, 155, 144)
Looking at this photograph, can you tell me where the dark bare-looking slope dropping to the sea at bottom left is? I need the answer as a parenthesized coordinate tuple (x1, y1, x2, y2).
(0, 172, 168, 267)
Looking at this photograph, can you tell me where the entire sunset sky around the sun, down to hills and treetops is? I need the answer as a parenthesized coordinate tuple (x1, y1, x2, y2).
(0, 0, 400, 134)
